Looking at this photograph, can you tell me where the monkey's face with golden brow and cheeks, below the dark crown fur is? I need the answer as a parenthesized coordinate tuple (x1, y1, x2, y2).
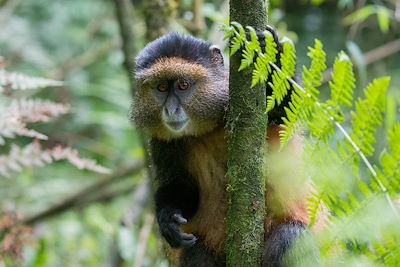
(131, 58, 228, 140)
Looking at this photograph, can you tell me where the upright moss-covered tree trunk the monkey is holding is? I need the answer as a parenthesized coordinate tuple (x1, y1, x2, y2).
(226, 0, 268, 266)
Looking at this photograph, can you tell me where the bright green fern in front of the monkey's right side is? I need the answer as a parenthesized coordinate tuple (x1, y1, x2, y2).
(225, 23, 400, 266)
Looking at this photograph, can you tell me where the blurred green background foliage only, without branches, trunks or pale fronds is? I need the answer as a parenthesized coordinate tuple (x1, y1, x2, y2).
(0, 0, 400, 267)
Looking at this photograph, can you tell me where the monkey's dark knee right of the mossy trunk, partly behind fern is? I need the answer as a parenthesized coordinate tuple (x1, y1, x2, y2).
(263, 222, 319, 267)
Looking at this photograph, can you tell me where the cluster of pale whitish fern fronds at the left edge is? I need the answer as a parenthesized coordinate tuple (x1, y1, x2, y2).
(0, 69, 109, 176)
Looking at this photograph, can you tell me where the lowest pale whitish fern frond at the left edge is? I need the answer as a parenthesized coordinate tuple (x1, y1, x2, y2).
(0, 141, 110, 177)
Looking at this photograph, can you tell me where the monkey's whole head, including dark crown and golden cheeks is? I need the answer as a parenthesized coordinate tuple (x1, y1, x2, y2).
(131, 33, 228, 140)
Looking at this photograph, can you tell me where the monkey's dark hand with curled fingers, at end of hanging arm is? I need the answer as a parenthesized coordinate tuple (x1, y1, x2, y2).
(157, 208, 197, 248)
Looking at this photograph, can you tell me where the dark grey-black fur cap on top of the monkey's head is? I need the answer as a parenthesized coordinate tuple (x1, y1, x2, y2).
(136, 32, 211, 71)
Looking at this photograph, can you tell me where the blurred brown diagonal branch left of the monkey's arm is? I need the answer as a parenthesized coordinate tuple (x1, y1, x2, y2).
(21, 161, 144, 225)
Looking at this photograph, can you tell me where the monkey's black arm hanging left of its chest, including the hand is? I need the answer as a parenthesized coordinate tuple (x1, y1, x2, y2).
(151, 140, 199, 248)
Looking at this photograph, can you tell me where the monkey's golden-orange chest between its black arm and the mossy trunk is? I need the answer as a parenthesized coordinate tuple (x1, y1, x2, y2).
(184, 131, 227, 254)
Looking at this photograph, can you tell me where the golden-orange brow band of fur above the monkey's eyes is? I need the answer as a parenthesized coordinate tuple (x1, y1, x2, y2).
(136, 57, 208, 83)
